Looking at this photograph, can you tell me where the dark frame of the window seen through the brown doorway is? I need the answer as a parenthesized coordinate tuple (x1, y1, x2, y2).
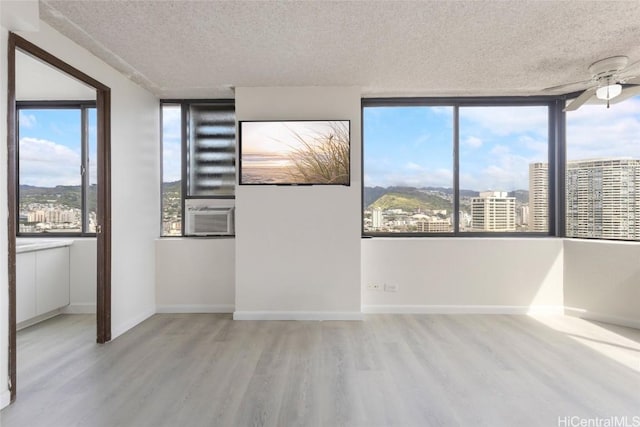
(16, 100, 97, 238)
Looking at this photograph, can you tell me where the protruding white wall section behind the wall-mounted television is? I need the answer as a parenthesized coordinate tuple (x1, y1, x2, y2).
(234, 87, 361, 319)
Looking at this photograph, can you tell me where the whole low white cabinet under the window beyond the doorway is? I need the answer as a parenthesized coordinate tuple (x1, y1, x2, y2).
(16, 246, 69, 323)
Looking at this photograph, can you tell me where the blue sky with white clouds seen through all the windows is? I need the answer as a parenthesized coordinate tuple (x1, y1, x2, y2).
(20, 97, 640, 191)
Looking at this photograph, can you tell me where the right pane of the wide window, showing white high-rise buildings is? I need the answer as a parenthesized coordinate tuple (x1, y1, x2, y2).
(459, 106, 549, 233)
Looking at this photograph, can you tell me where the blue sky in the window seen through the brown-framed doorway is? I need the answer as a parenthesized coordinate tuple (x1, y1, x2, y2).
(19, 109, 96, 187)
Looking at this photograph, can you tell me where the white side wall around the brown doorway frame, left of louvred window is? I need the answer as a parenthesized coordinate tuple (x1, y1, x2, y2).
(12, 22, 160, 338)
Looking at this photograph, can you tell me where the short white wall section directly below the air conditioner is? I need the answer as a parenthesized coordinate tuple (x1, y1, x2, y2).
(156, 238, 236, 313)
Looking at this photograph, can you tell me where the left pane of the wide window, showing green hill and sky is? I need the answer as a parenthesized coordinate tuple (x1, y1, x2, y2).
(363, 106, 454, 233)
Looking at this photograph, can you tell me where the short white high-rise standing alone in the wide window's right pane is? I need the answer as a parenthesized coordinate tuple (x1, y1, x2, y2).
(471, 191, 516, 231)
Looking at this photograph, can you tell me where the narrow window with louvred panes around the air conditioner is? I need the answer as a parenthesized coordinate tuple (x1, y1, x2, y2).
(162, 100, 236, 236)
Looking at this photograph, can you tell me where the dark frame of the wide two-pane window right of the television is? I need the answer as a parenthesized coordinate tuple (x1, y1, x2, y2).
(360, 96, 567, 238)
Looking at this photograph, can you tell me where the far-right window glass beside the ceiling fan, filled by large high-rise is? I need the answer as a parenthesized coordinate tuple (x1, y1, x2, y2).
(565, 97, 640, 240)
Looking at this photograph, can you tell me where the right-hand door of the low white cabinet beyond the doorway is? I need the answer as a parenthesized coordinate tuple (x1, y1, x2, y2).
(36, 247, 69, 314)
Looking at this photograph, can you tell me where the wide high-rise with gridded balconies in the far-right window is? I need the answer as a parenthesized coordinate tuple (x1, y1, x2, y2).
(566, 159, 640, 239)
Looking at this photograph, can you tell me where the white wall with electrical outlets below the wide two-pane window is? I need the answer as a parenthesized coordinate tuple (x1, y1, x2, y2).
(362, 238, 563, 313)
